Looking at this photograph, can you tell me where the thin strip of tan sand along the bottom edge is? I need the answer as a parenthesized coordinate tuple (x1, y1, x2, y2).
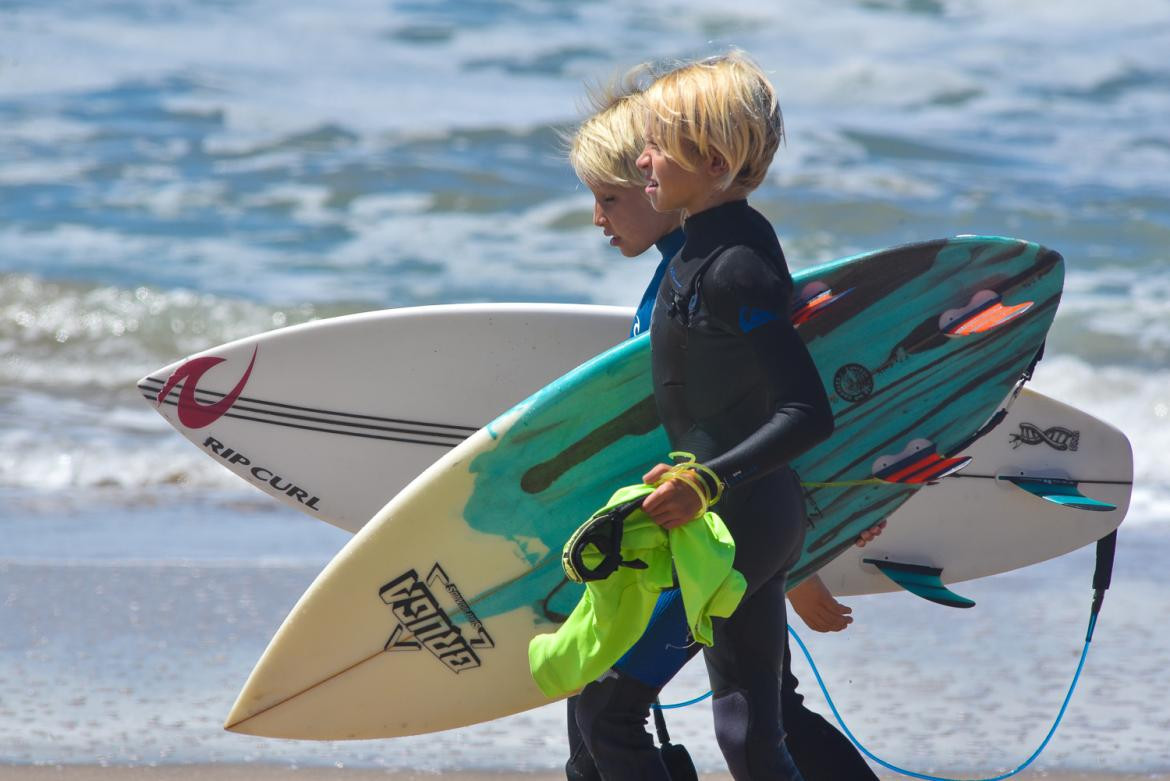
(0, 763, 1170, 781)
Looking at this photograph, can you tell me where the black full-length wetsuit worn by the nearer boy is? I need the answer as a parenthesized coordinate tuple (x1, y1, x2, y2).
(577, 201, 833, 780)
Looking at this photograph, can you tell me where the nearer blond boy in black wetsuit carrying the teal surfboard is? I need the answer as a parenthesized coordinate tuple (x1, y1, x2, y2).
(577, 53, 832, 780)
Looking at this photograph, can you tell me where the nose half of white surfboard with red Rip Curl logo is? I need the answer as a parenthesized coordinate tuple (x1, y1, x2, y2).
(138, 304, 634, 532)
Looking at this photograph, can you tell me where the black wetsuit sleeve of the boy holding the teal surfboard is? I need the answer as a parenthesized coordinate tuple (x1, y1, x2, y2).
(703, 247, 833, 488)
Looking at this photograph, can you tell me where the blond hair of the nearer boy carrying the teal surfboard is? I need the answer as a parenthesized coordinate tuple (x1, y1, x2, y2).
(641, 49, 784, 192)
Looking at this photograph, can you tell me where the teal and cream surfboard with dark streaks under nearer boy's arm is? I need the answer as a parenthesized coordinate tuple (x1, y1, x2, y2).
(219, 236, 1064, 739)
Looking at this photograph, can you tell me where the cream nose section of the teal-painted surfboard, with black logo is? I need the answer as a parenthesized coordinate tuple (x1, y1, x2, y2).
(225, 413, 548, 740)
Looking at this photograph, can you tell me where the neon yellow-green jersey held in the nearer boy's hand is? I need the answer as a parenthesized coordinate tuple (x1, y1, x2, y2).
(528, 485, 746, 697)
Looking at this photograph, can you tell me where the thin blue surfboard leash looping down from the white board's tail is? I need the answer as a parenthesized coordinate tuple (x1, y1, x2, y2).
(653, 530, 1117, 781)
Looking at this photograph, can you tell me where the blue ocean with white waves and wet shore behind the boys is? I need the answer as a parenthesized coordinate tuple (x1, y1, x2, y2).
(0, 0, 1170, 772)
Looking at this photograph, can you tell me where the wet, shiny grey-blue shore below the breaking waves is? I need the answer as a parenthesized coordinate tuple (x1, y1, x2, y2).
(0, 537, 1170, 781)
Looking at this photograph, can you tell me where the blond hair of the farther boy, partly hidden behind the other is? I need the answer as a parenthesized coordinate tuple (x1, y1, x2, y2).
(569, 67, 648, 187)
